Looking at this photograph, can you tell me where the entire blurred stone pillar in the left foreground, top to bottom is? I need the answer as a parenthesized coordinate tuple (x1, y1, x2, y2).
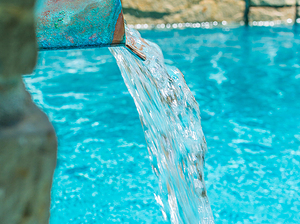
(0, 0, 57, 224)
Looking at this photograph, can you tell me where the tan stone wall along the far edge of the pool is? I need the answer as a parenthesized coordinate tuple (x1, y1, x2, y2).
(122, 0, 300, 24)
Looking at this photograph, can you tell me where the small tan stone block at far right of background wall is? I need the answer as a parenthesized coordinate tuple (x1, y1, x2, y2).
(249, 6, 296, 22)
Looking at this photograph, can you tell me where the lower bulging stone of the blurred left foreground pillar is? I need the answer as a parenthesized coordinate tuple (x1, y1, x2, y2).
(0, 93, 57, 224)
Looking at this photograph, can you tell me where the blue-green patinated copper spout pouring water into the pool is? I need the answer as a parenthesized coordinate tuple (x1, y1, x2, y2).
(36, 0, 126, 50)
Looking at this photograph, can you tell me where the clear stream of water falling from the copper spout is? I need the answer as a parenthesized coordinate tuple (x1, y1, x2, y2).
(110, 27, 214, 224)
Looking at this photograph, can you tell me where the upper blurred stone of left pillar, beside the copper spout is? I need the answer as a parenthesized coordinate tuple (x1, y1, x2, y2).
(0, 0, 37, 77)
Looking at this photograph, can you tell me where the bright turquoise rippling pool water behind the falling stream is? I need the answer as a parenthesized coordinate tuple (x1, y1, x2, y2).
(25, 27, 300, 224)
